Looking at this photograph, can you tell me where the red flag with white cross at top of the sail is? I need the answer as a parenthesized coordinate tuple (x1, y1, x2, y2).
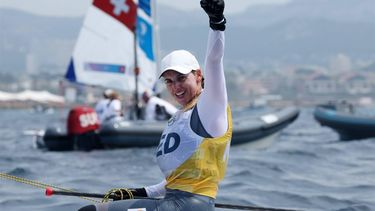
(93, 0, 137, 31)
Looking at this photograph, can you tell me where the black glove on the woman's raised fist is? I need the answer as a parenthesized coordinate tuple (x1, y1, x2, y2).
(201, 0, 226, 31)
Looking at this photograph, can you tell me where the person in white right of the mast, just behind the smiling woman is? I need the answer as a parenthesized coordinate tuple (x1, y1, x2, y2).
(142, 90, 178, 121)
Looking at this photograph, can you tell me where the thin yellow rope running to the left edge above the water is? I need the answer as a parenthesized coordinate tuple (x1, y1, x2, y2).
(0, 172, 101, 203)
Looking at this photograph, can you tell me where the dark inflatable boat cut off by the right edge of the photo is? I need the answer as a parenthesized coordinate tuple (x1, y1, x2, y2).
(314, 104, 375, 140)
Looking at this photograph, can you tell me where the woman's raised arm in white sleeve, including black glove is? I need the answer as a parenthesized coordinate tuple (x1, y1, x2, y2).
(197, 0, 228, 137)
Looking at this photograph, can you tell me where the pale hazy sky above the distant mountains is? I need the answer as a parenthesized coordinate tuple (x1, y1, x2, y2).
(0, 0, 291, 17)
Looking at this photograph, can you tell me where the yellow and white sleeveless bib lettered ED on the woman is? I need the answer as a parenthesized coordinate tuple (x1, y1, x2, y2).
(157, 107, 232, 198)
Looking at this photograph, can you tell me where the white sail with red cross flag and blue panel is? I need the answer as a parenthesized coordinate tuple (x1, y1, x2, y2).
(65, 0, 157, 92)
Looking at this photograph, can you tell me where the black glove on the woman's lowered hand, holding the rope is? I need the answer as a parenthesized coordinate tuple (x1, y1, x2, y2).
(103, 188, 147, 201)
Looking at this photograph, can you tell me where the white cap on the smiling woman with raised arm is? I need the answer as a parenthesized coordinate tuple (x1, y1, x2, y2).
(159, 50, 200, 78)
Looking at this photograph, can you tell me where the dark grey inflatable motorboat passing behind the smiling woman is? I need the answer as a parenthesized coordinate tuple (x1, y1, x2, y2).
(36, 107, 299, 151)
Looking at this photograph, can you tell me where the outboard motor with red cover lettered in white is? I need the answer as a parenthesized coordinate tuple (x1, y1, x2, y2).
(67, 106, 102, 150)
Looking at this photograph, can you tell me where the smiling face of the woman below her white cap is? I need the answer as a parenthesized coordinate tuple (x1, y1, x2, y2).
(162, 70, 202, 107)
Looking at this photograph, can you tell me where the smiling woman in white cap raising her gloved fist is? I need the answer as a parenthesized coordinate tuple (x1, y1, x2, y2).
(79, 0, 232, 211)
